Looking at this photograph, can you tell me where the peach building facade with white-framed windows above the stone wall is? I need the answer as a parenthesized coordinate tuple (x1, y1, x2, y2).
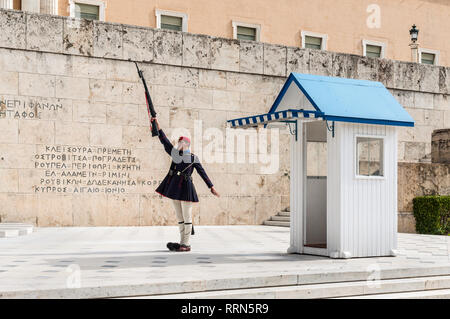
(0, 0, 450, 66)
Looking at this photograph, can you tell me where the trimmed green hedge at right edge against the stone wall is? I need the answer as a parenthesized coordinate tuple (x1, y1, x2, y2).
(413, 196, 450, 235)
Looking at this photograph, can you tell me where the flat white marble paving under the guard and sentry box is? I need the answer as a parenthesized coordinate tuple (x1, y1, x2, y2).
(0, 226, 450, 294)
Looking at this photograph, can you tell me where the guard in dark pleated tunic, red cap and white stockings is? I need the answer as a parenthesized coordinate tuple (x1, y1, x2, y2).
(151, 117, 220, 251)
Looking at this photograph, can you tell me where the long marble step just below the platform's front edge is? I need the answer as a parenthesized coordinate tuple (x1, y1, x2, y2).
(127, 275, 450, 299)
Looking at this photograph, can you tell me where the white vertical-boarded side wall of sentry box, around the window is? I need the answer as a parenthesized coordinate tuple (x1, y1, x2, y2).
(327, 122, 397, 258)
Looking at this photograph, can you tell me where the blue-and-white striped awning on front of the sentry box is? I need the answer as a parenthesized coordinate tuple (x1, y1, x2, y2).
(227, 109, 322, 128)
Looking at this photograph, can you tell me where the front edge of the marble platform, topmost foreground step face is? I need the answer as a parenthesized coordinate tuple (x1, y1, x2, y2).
(6, 264, 450, 299)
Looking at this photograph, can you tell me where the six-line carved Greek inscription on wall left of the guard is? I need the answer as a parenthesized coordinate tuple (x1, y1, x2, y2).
(33, 145, 161, 194)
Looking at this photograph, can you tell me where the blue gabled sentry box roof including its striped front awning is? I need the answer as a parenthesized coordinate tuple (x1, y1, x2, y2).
(228, 73, 414, 127)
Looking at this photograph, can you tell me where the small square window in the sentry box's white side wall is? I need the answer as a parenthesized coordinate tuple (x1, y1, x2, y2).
(356, 136, 384, 176)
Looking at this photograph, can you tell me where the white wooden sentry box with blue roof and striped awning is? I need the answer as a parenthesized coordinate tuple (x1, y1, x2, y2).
(228, 73, 414, 258)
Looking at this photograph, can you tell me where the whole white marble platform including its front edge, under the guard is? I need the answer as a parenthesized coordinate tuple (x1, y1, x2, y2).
(0, 225, 450, 298)
